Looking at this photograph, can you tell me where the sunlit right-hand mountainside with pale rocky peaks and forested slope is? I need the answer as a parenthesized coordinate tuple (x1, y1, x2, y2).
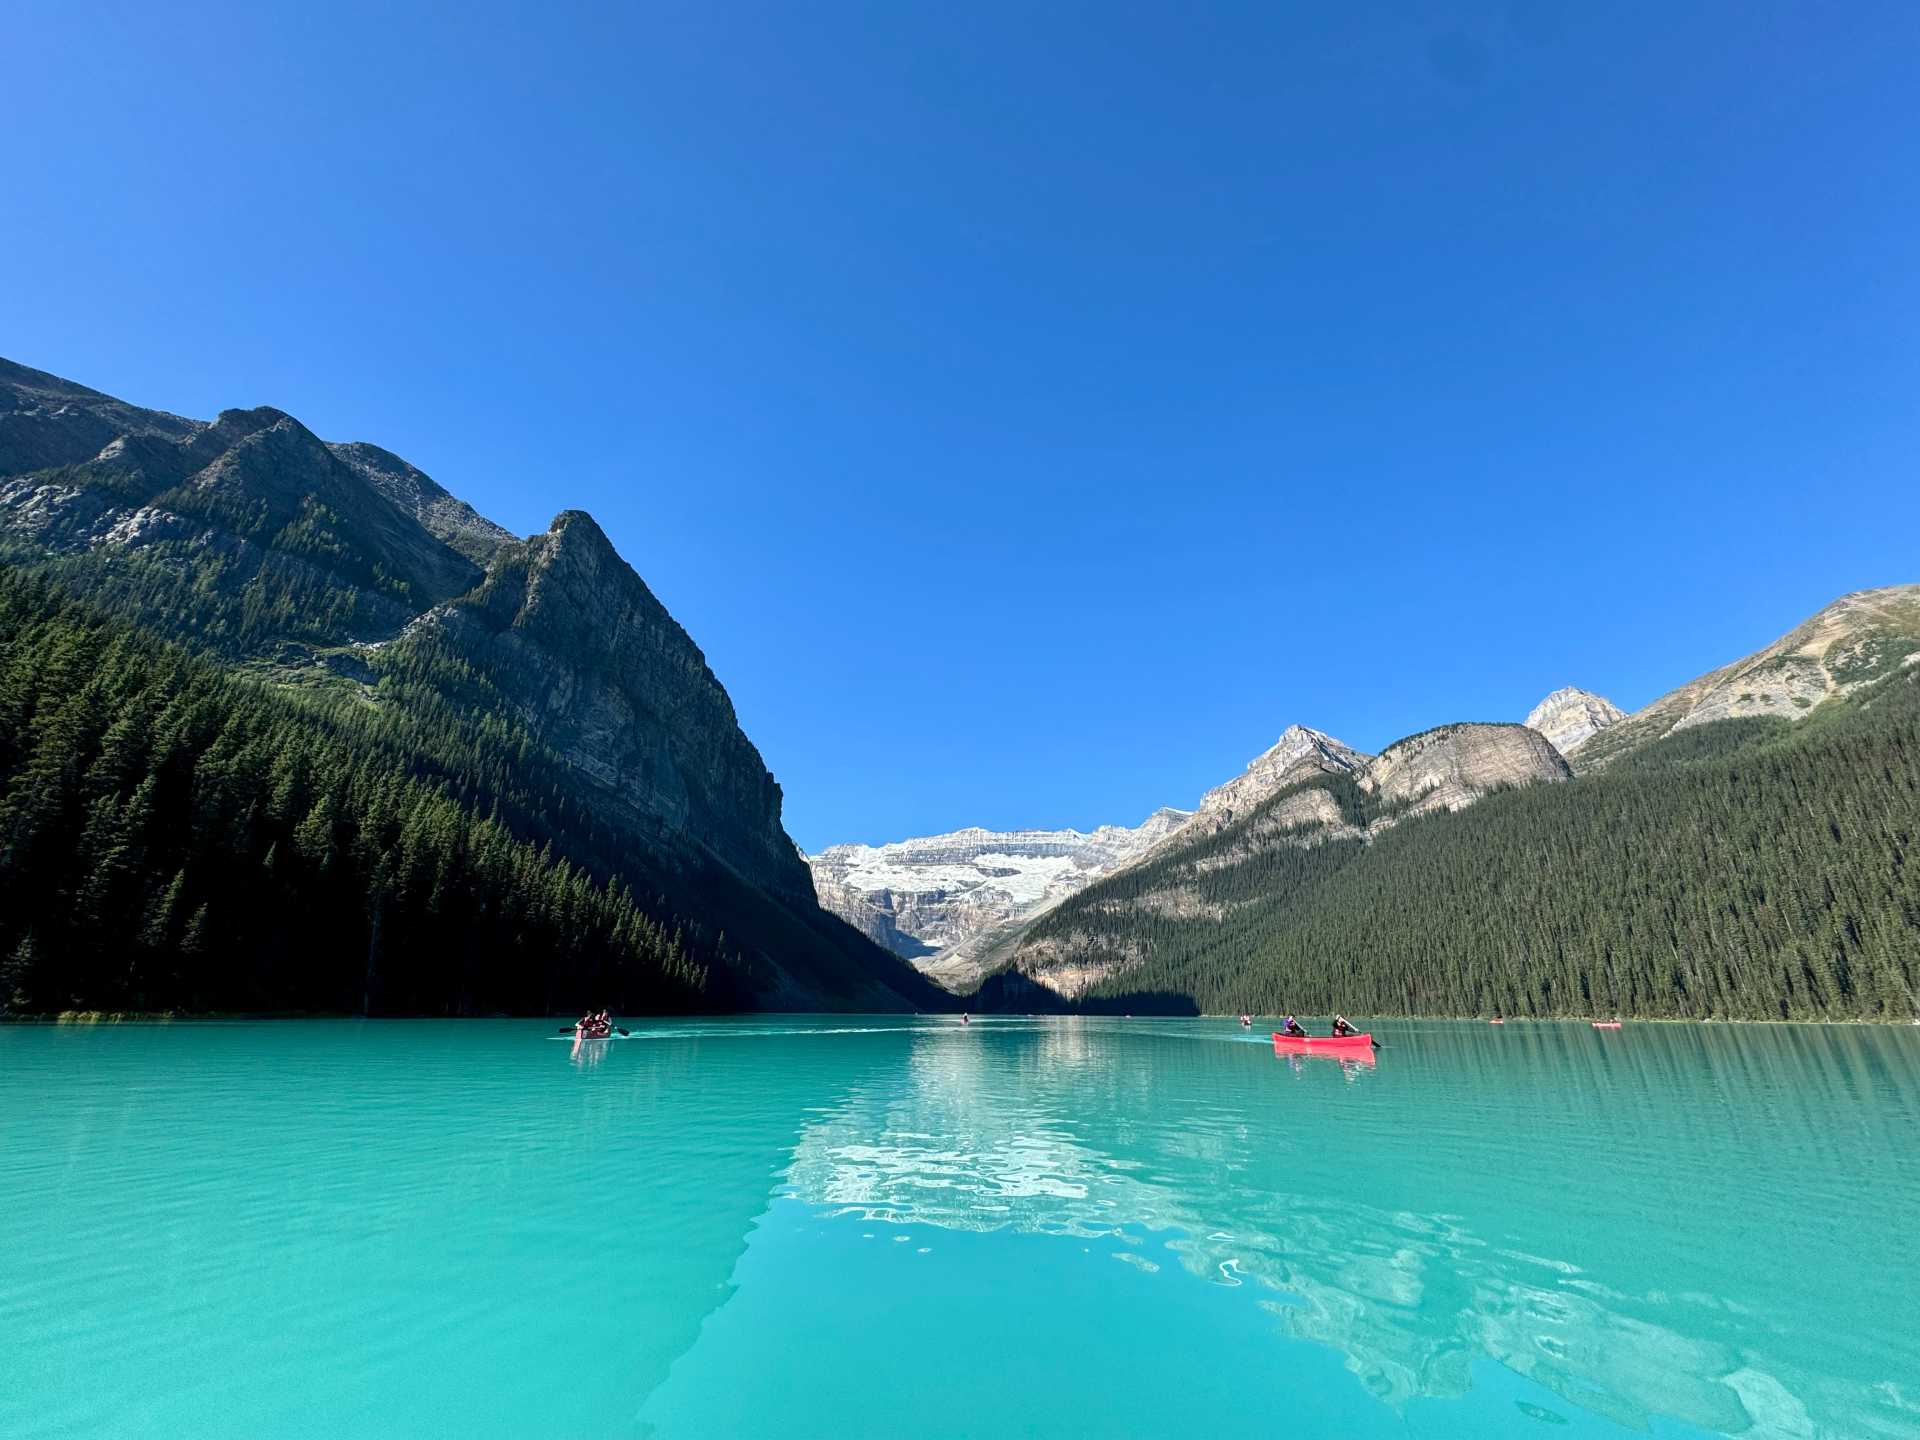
(814, 586, 1920, 1016)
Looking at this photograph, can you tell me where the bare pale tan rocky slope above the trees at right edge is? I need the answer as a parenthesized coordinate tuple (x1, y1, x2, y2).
(1578, 586, 1920, 770)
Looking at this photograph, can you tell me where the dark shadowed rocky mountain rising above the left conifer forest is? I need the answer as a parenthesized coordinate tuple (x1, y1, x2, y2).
(0, 361, 937, 1010)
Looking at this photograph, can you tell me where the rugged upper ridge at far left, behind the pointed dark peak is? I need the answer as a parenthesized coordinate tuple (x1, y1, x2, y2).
(0, 363, 482, 664)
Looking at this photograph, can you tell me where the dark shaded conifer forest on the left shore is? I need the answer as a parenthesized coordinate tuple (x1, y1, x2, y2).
(0, 568, 726, 1014)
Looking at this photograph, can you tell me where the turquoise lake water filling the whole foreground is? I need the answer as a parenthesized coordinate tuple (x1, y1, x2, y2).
(0, 1018, 1920, 1440)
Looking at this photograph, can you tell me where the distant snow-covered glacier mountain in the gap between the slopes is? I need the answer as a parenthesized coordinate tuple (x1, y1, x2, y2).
(808, 808, 1188, 985)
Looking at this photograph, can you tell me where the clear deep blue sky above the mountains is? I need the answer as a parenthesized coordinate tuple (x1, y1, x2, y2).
(11, 0, 1920, 849)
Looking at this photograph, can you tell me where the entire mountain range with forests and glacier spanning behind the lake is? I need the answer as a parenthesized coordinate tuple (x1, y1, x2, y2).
(0, 361, 1920, 1020)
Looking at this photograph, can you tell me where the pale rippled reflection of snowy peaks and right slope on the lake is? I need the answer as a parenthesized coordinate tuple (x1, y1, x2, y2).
(789, 1021, 1920, 1436)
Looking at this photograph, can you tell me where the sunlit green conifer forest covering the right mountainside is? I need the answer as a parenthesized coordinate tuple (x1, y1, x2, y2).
(1016, 666, 1920, 1020)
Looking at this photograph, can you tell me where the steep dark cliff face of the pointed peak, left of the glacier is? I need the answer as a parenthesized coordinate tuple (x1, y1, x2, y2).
(408, 511, 812, 902)
